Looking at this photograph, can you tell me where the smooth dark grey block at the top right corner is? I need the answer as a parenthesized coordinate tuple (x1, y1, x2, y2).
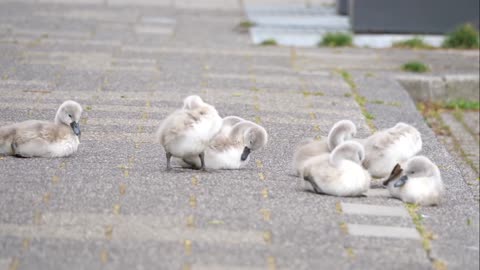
(349, 0, 479, 34)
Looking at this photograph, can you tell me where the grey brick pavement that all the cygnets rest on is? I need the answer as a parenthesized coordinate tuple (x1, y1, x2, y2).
(0, 0, 479, 270)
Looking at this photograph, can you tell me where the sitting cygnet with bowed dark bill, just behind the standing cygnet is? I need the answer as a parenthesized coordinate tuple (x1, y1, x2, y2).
(183, 121, 268, 169)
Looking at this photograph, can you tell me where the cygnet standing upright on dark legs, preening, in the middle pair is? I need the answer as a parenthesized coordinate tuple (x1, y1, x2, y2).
(157, 96, 222, 170)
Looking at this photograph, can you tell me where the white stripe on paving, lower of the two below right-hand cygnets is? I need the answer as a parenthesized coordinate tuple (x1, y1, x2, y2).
(347, 224, 421, 240)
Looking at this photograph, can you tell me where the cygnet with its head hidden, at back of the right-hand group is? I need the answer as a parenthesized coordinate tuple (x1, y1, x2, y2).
(358, 123, 422, 178)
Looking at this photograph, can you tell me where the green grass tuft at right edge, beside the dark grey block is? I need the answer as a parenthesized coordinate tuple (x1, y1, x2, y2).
(442, 24, 480, 49)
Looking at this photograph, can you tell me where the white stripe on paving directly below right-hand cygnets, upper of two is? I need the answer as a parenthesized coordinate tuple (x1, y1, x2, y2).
(341, 202, 410, 217)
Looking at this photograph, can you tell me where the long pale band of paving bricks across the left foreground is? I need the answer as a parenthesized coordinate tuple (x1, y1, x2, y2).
(0, 213, 265, 245)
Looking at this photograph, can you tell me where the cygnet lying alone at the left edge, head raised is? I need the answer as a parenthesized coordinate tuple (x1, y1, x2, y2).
(0, 100, 82, 157)
